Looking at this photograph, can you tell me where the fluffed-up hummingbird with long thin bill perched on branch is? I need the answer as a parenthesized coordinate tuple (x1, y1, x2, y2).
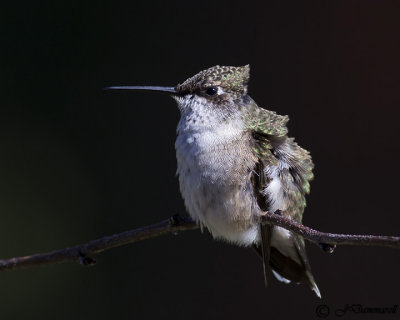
(106, 65, 321, 297)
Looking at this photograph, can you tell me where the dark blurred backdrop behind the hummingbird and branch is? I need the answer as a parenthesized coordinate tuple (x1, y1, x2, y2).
(0, 0, 400, 319)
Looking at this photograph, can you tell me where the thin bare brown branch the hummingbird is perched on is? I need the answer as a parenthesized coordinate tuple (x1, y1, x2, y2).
(0, 212, 400, 271)
